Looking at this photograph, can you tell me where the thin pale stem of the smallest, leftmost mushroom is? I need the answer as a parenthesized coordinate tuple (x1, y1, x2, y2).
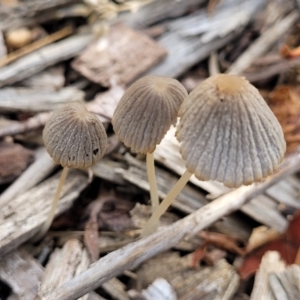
(33, 167, 69, 242)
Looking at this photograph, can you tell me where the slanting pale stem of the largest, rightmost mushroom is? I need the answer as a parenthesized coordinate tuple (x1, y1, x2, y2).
(141, 170, 193, 237)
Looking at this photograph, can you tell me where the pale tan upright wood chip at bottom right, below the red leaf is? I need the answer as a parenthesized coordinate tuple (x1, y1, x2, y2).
(250, 251, 285, 300)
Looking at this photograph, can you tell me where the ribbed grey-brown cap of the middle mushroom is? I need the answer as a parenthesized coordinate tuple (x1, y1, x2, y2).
(112, 75, 187, 154)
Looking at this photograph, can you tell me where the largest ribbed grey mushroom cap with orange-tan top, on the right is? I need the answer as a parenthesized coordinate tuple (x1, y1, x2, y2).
(176, 74, 286, 187)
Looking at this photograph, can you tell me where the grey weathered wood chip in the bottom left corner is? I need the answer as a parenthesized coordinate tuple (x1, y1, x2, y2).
(0, 250, 44, 300)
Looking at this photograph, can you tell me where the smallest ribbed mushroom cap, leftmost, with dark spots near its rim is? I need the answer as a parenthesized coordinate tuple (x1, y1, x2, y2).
(43, 102, 107, 168)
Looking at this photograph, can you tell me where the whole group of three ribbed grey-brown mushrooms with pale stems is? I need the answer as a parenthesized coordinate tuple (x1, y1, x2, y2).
(39, 74, 286, 236)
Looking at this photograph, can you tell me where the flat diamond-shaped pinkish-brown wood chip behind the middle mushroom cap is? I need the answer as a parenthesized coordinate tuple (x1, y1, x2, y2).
(72, 24, 167, 87)
